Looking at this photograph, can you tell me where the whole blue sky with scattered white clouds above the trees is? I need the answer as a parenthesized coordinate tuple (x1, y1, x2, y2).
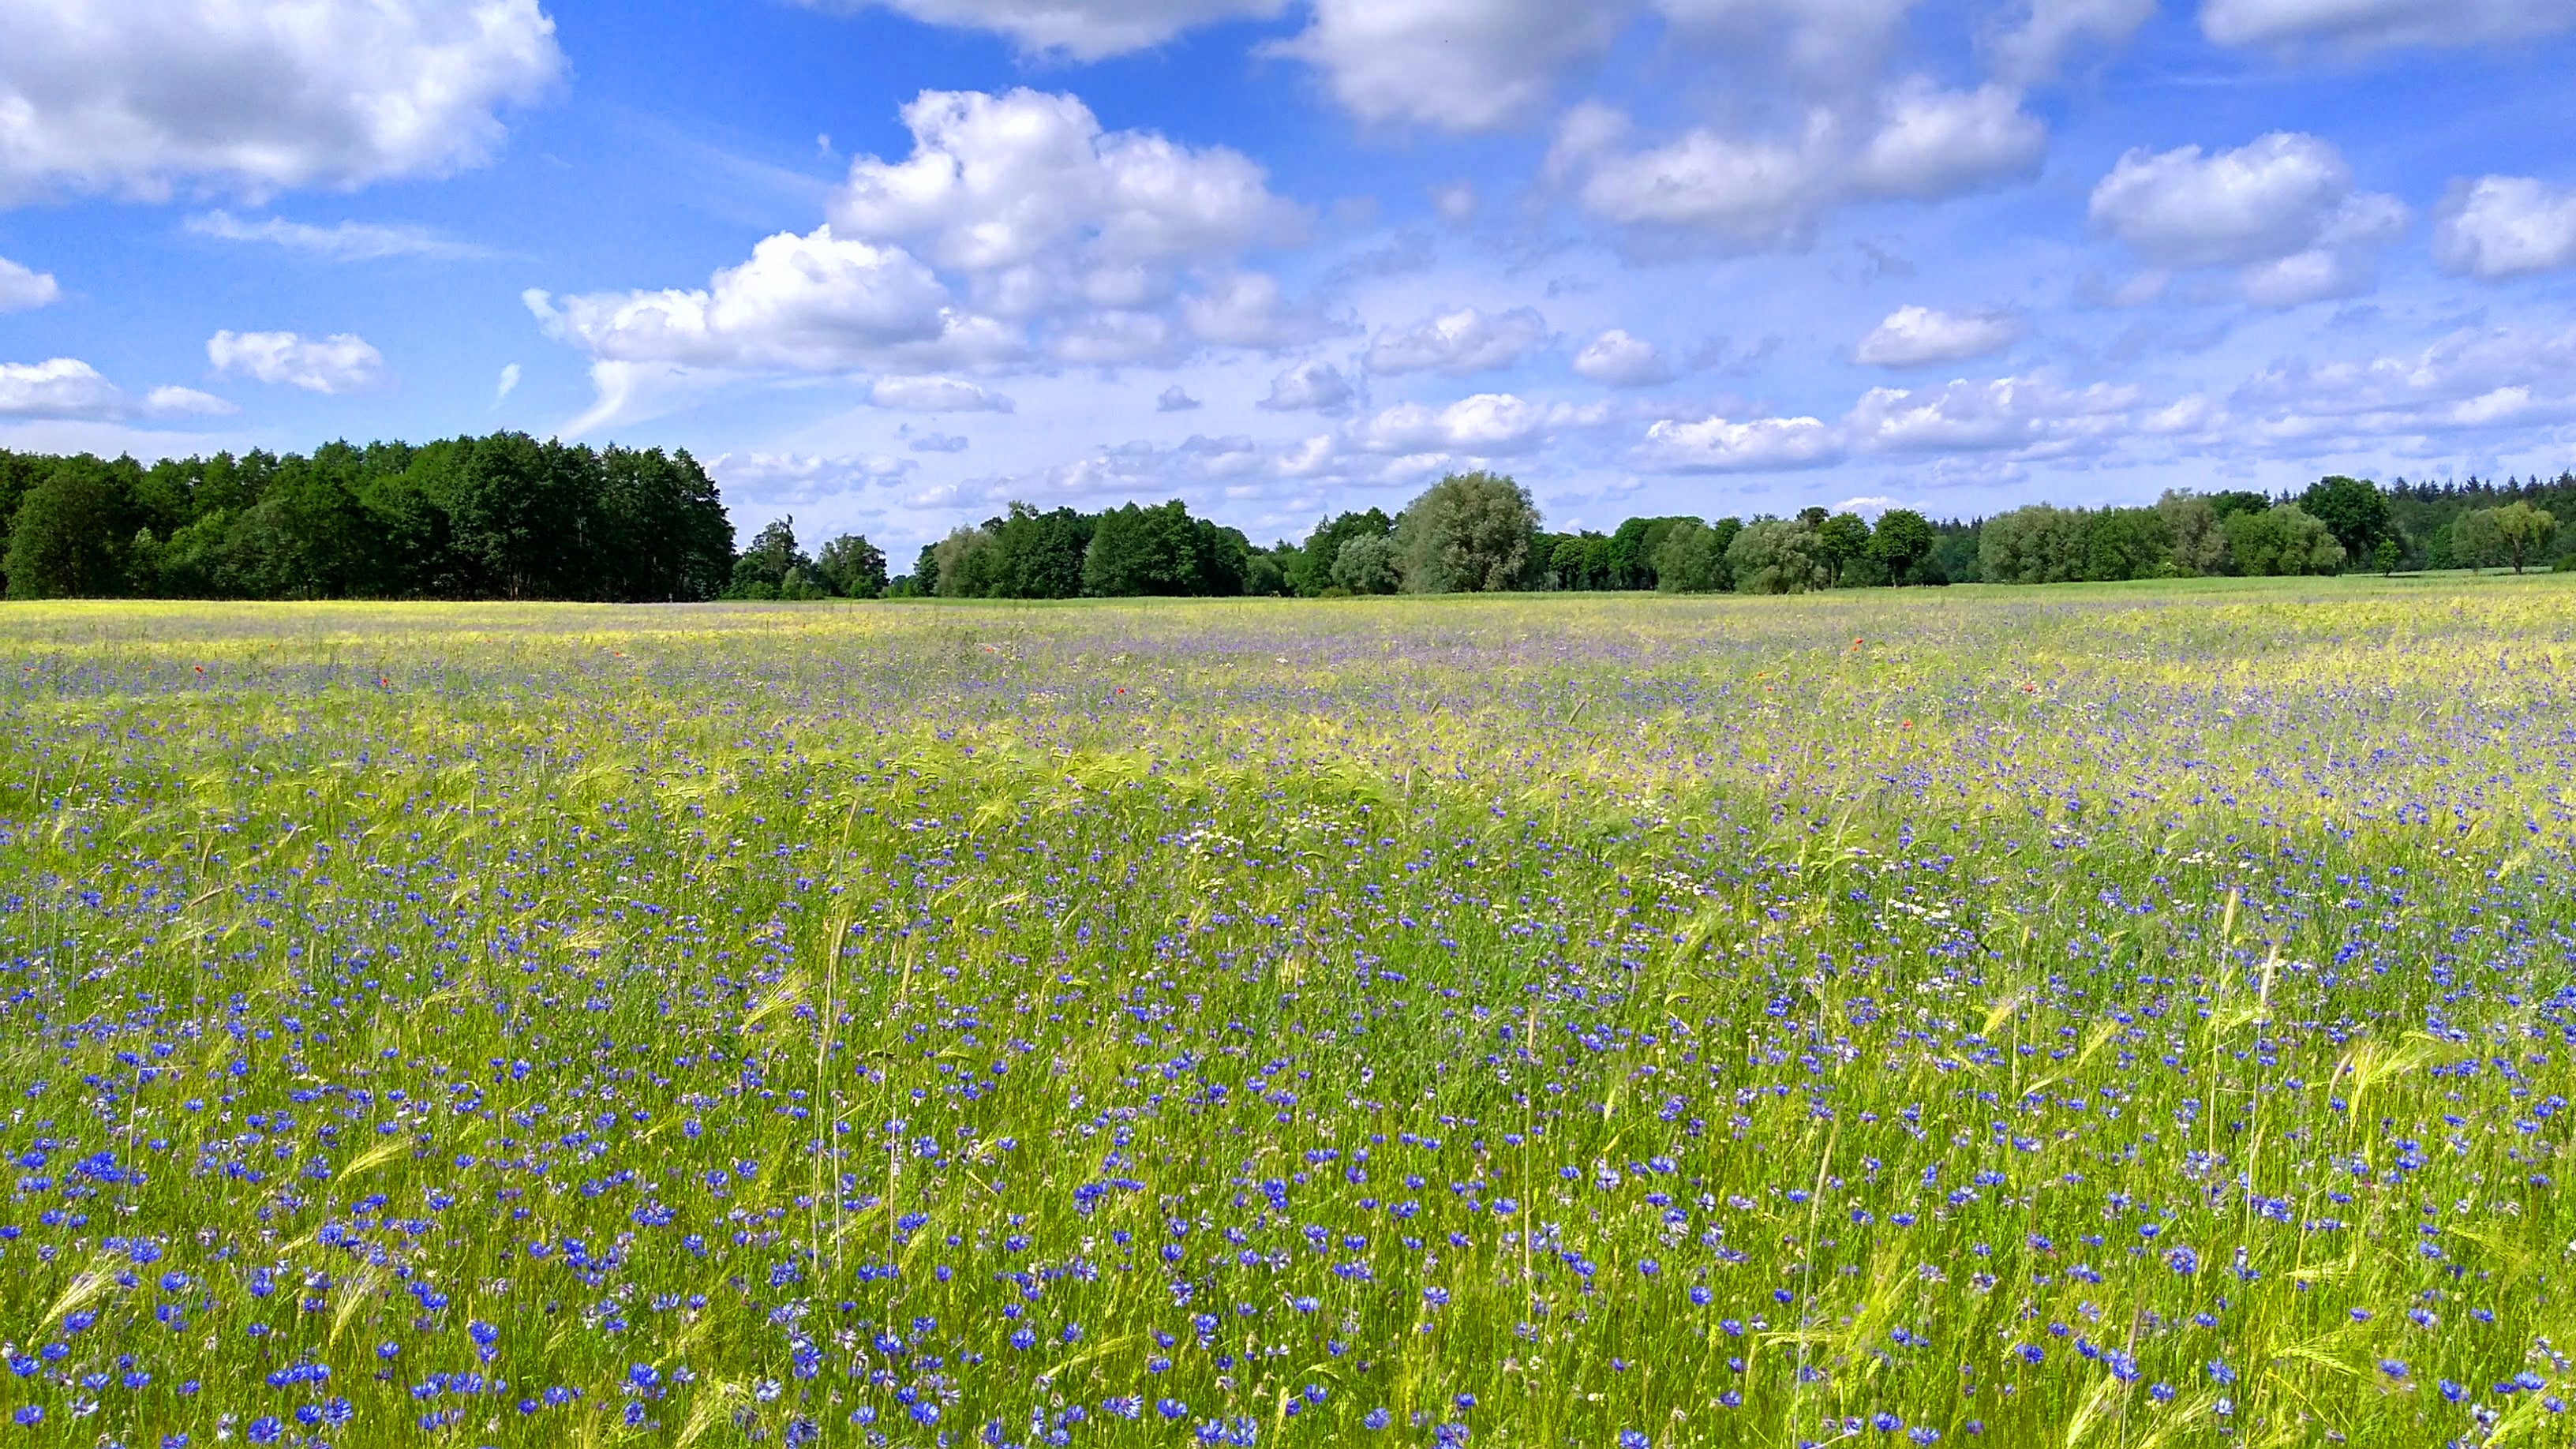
(0, 0, 2576, 549)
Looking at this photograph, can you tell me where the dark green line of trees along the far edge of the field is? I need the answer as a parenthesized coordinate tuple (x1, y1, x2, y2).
(0, 433, 2576, 601)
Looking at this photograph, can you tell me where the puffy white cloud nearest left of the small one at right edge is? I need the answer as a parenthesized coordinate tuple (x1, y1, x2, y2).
(2089, 132, 2406, 307)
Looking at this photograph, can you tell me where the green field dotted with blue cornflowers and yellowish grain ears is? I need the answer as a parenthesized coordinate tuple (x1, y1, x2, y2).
(0, 575, 2576, 1449)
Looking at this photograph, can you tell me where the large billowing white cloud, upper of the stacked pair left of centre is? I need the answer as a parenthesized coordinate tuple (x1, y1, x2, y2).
(829, 90, 1304, 271)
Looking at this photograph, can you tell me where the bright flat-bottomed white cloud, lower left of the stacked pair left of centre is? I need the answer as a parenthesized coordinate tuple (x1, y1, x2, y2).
(526, 227, 1017, 371)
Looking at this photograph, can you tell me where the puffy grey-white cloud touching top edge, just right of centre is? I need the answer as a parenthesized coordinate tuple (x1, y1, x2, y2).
(1272, 0, 1628, 132)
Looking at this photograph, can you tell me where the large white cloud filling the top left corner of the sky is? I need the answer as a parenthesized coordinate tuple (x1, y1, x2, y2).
(0, 0, 564, 199)
